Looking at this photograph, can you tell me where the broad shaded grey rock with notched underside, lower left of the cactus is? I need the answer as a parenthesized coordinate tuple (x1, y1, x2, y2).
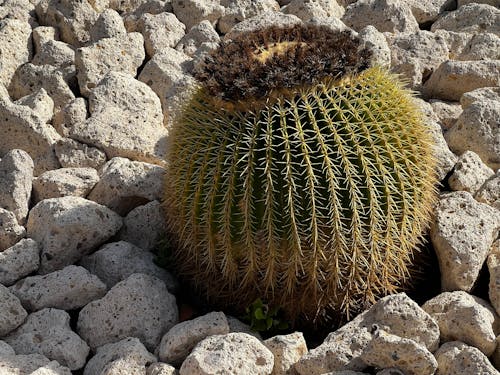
(77, 273, 179, 351)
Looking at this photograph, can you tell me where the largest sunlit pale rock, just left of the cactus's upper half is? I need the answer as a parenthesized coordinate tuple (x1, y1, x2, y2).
(69, 72, 167, 164)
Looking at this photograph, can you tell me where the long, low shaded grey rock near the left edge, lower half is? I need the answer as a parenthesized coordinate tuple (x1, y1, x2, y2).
(10, 265, 107, 311)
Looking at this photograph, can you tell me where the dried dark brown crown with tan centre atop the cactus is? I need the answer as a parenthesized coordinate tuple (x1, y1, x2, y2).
(195, 25, 371, 104)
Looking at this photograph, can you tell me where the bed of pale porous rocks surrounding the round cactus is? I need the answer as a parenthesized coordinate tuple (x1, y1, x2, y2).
(0, 0, 500, 375)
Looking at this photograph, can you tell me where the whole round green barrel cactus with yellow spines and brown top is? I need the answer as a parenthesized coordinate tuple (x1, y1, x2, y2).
(164, 26, 436, 324)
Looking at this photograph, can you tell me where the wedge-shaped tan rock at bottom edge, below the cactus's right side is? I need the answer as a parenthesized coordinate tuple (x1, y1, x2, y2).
(361, 329, 437, 375)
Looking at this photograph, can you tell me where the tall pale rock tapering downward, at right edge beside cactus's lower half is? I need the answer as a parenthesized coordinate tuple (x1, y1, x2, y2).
(431, 191, 500, 292)
